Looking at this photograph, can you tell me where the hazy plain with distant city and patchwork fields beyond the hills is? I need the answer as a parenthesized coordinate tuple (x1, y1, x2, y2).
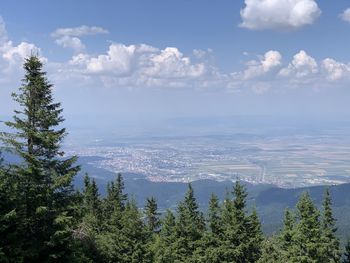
(66, 124, 350, 188)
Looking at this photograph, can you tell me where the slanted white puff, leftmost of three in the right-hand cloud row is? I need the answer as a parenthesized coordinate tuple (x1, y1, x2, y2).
(244, 50, 282, 79)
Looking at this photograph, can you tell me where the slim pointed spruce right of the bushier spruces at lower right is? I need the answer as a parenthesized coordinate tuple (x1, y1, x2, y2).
(321, 187, 341, 262)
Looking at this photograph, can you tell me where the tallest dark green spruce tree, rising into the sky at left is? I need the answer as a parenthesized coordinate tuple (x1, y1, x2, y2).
(2, 55, 79, 262)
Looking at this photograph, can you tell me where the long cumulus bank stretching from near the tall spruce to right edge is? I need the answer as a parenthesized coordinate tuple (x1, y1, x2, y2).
(56, 46, 350, 94)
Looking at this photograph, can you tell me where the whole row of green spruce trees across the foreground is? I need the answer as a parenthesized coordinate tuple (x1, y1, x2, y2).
(0, 56, 350, 263)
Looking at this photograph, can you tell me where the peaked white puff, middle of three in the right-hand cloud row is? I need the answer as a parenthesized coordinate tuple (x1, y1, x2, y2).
(279, 50, 318, 78)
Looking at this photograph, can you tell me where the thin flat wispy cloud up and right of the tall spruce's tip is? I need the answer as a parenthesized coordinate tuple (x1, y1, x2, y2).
(51, 26, 108, 52)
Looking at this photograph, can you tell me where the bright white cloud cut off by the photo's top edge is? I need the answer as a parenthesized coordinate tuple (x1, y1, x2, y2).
(240, 0, 321, 30)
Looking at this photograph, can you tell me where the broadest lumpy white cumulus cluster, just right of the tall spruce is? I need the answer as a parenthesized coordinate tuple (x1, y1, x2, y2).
(62, 43, 209, 87)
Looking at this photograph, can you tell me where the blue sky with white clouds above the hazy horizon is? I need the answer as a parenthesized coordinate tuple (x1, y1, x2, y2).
(0, 0, 350, 128)
